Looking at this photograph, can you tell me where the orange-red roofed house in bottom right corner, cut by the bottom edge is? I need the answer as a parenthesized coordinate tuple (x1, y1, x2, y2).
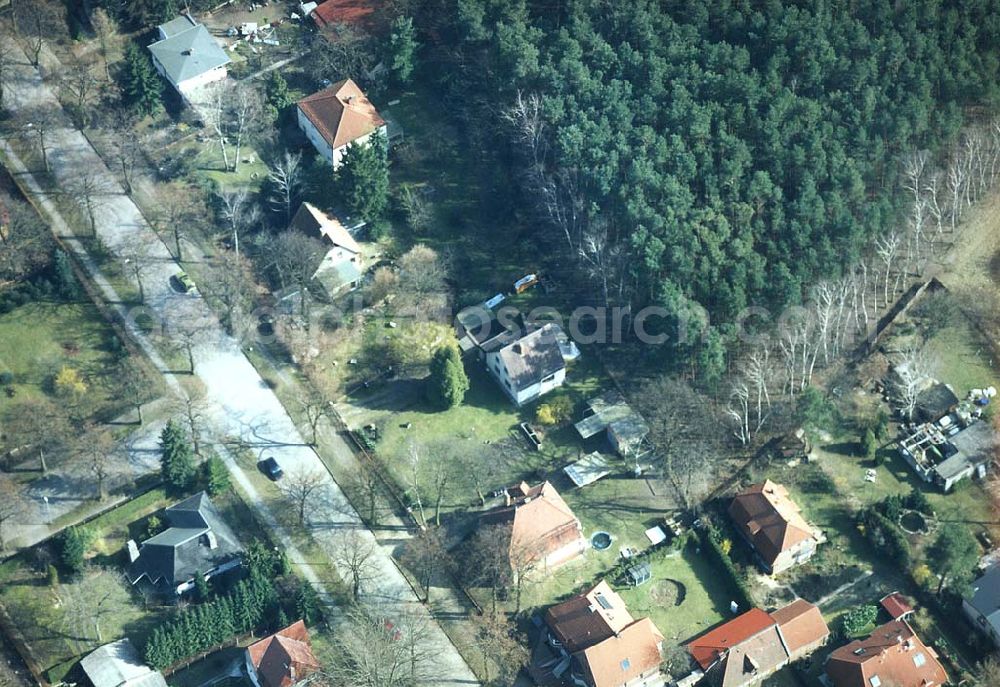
(826, 620, 948, 687)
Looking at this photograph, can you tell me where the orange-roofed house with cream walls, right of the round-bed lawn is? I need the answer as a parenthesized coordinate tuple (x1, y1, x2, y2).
(729, 480, 822, 575)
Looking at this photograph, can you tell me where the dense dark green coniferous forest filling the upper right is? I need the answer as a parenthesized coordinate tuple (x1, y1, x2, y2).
(424, 0, 1000, 328)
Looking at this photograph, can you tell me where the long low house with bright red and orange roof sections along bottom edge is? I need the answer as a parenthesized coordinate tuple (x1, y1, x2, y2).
(688, 599, 830, 687)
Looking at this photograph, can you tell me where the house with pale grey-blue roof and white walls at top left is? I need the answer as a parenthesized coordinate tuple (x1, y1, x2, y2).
(149, 14, 230, 103)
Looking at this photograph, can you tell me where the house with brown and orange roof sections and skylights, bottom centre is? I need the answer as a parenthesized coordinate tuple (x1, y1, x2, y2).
(531, 580, 663, 687)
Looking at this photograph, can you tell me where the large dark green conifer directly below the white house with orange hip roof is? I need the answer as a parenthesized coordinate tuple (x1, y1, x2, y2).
(334, 131, 389, 222)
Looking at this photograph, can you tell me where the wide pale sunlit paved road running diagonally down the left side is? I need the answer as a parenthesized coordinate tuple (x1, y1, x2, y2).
(5, 47, 476, 685)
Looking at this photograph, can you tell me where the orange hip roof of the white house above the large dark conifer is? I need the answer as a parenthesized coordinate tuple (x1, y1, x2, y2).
(298, 79, 385, 149)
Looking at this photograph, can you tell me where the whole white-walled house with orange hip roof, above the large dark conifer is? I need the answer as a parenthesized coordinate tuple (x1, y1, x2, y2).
(297, 77, 388, 169)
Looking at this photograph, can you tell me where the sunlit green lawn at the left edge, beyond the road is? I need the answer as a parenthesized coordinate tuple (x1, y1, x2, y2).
(0, 302, 124, 438)
